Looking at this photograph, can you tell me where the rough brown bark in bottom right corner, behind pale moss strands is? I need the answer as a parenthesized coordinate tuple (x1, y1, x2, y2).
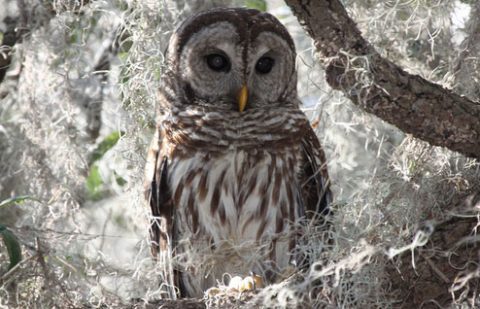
(386, 217, 480, 309)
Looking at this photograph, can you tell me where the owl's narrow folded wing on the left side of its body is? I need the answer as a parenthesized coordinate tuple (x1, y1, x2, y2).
(145, 130, 173, 258)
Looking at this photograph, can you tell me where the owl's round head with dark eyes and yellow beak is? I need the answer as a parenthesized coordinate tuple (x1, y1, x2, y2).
(168, 8, 297, 112)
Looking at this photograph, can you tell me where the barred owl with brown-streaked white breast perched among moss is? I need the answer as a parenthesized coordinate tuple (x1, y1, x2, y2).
(145, 8, 331, 297)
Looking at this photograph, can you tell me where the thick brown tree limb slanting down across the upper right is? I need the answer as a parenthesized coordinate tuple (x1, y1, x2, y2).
(285, 0, 480, 159)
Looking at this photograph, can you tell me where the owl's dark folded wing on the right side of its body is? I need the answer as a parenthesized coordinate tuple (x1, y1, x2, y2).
(300, 125, 332, 219)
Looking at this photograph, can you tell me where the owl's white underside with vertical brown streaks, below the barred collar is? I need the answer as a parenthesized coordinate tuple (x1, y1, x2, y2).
(170, 147, 299, 294)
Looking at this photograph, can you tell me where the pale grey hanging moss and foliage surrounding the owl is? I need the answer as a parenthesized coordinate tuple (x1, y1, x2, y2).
(0, 0, 480, 308)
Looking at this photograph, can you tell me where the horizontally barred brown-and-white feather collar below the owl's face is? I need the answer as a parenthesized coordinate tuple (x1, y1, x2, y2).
(161, 106, 308, 152)
